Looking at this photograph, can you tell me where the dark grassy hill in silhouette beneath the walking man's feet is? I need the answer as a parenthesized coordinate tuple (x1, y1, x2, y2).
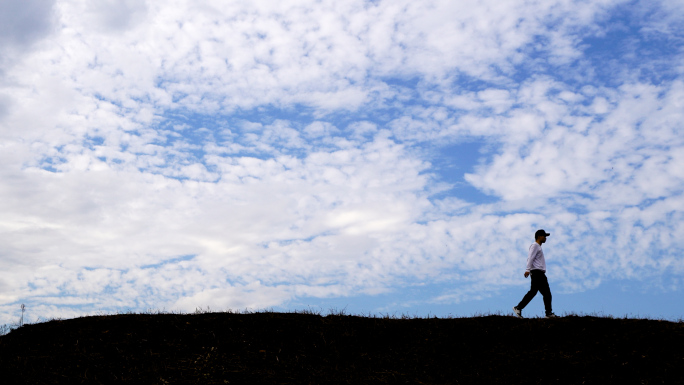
(0, 313, 684, 385)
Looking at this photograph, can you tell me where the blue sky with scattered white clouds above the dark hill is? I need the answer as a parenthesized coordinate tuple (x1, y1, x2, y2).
(0, 0, 684, 323)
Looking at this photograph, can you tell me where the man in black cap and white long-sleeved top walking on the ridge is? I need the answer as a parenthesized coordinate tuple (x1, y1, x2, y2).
(513, 230, 556, 318)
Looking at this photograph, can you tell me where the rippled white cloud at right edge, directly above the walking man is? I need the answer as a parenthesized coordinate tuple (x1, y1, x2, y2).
(466, 82, 683, 205)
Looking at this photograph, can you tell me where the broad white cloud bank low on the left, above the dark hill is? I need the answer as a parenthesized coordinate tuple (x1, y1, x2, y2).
(2, 129, 438, 318)
